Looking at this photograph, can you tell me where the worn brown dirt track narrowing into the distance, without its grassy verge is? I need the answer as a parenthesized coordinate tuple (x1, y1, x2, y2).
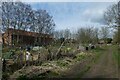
(82, 47, 118, 78)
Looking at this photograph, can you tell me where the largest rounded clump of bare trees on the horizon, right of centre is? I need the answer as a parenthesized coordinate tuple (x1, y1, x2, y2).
(77, 27, 99, 44)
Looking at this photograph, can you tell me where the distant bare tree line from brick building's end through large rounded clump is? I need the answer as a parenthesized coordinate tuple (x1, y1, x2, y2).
(54, 27, 99, 44)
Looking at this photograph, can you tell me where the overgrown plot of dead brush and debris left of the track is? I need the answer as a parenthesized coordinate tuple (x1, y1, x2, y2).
(2, 43, 99, 79)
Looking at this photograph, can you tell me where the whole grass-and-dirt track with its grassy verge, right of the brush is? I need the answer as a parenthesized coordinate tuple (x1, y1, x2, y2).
(64, 45, 119, 78)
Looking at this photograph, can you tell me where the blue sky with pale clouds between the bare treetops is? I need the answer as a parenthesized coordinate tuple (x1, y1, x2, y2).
(28, 2, 114, 31)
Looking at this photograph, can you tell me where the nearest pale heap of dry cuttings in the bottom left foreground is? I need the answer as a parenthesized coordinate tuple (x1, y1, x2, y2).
(10, 66, 52, 79)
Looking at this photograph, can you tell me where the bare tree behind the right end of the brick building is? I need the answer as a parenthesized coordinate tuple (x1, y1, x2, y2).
(33, 10, 55, 34)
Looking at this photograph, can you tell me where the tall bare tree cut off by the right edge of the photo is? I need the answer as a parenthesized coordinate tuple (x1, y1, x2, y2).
(104, 2, 120, 43)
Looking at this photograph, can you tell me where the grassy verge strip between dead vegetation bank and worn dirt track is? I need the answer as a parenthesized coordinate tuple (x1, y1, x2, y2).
(62, 48, 104, 78)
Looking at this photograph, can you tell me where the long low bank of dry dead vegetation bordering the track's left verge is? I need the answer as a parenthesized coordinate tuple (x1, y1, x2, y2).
(10, 52, 95, 78)
